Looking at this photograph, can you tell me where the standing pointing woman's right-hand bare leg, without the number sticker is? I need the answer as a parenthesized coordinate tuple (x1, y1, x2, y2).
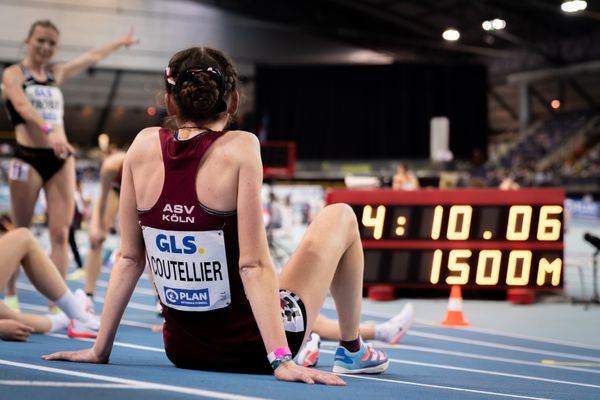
(44, 157, 75, 278)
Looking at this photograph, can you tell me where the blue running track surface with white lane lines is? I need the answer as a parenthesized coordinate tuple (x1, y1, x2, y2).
(0, 260, 600, 400)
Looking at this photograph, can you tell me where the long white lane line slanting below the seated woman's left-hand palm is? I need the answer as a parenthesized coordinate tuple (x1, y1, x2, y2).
(0, 359, 264, 400)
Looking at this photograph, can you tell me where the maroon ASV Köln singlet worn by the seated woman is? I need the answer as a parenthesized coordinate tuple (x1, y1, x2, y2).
(138, 129, 272, 373)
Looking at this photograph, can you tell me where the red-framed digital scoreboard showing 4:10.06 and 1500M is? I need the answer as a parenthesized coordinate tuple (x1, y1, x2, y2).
(326, 188, 565, 289)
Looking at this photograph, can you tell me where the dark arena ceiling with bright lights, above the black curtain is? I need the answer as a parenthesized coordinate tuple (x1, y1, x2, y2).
(195, 0, 600, 77)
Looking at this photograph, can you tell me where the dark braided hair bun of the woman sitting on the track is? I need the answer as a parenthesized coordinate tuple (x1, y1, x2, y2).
(165, 47, 238, 121)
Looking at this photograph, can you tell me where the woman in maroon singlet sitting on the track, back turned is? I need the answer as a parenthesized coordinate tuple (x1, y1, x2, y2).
(44, 47, 389, 385)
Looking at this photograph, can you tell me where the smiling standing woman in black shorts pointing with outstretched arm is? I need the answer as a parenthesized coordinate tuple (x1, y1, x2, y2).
(2, 20, 138, 307)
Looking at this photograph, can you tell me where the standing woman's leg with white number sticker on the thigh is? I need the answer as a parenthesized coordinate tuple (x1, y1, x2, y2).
(2, 158, 43, 296)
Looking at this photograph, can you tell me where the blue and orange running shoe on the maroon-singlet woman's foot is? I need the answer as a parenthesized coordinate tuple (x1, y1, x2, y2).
(333, 340, 390, 374)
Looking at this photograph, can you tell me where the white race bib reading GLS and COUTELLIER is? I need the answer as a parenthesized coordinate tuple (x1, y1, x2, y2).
(142, 227, 231, 312)
